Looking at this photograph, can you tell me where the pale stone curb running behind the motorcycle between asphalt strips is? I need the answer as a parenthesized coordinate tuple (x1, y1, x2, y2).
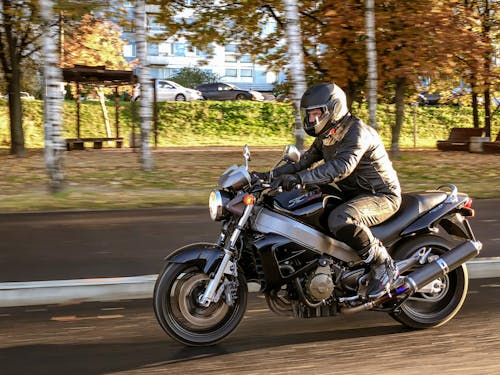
(0, 257, 500, 308)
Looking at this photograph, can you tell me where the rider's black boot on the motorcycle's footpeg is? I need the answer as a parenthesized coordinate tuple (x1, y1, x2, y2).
(365, 241, 399, 299)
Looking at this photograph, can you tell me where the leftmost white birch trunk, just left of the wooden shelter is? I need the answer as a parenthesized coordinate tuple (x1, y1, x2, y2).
(40, 0, 65, 193)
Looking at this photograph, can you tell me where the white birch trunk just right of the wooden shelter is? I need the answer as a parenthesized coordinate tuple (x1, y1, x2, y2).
(135, 0, 154, 171)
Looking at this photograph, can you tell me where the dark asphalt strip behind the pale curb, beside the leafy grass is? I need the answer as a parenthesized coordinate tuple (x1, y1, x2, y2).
(0, 199, 500, 282)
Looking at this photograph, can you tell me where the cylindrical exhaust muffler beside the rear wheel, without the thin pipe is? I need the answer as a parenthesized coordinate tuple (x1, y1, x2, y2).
(404, 241, 483, 295)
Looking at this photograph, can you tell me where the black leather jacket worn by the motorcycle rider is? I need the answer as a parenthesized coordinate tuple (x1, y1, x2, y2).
(273, 114, 401, 197)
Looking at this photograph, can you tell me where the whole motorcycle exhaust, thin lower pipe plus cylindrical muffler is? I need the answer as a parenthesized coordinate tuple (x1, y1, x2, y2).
(341, 240, 483, 313)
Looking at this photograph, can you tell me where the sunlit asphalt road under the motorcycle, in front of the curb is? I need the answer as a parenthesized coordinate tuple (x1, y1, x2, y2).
(0, 279, 500, 375)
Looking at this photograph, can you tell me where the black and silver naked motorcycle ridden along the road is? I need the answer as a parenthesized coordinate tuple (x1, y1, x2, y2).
(153, 145, 482, 346)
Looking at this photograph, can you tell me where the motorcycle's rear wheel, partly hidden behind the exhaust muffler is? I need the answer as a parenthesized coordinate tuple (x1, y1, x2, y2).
(390, 235, 469, 329)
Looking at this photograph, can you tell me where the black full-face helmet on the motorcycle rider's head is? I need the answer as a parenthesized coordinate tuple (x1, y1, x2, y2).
(300, 83, 348, 137)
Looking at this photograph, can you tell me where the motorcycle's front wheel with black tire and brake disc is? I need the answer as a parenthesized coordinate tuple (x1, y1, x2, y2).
(153, 264, 248, 346)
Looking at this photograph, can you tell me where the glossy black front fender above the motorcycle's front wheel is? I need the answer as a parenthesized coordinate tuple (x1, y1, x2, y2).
(165, 242, 224, 275)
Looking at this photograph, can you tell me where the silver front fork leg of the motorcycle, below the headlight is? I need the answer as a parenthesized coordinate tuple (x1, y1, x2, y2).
(198, 205, 253, 307)
